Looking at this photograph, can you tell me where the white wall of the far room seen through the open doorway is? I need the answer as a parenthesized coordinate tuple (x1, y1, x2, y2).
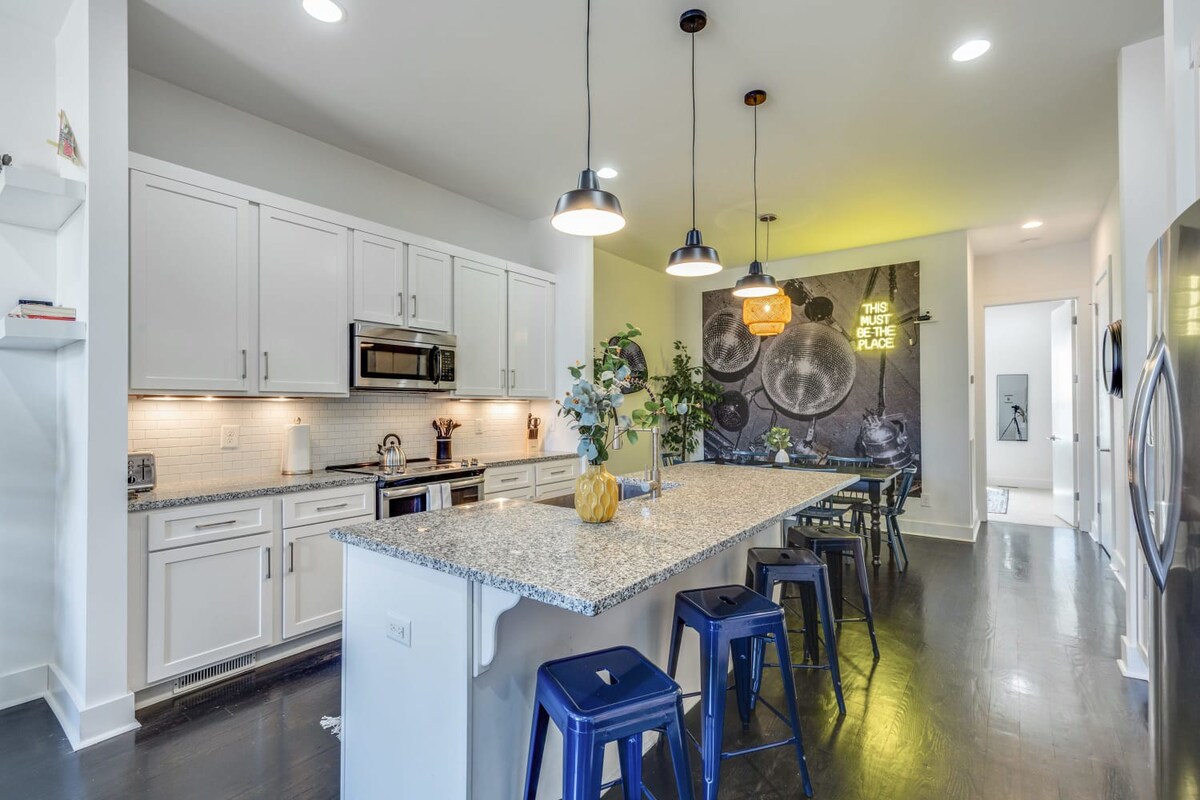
(982, 301, 1062, 489)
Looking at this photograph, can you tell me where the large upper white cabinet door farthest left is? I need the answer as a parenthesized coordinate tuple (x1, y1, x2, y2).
(130, 172, 253, 392)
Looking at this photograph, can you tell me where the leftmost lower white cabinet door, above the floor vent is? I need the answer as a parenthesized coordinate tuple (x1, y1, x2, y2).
(146, 534, 276, 684)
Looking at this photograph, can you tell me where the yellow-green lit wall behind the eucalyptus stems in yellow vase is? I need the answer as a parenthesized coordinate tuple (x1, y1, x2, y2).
(593, 249, 677, 475)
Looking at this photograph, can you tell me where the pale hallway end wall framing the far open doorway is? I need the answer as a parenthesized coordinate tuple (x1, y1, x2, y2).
(974, 241, 1096, 530)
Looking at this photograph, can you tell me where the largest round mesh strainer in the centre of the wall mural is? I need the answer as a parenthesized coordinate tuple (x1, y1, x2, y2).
(762, 323, 858, 416)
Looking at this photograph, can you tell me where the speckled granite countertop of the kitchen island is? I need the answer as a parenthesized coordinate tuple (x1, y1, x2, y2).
(331, 463, 856, 616)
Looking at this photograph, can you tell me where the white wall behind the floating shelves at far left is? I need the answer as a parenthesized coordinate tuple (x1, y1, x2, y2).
(0, 11, 58, 708)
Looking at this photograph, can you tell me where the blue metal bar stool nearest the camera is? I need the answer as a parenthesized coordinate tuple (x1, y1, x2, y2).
(523, 648, 692, 800)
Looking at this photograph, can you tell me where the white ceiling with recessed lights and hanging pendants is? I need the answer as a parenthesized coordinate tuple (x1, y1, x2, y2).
(130, 0, 1162, 267)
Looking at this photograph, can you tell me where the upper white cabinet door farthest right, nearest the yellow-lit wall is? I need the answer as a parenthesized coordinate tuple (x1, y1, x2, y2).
(509, 272, 554, 397)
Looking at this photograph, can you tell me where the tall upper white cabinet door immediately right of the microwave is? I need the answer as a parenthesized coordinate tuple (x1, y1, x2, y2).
(454, 258, 509, 397)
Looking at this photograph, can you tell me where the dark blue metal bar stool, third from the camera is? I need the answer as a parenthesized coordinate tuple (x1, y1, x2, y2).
(746, 547, 846, 715)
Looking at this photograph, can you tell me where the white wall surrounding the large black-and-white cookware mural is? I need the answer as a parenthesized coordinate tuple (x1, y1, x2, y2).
(674, 231, 977, 541)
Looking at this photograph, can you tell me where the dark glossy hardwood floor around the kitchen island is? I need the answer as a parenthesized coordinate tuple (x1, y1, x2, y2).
(0, 524, 1152, 800)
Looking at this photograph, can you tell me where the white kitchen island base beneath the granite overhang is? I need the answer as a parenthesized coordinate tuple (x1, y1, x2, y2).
(342, 525, 781, 800)
